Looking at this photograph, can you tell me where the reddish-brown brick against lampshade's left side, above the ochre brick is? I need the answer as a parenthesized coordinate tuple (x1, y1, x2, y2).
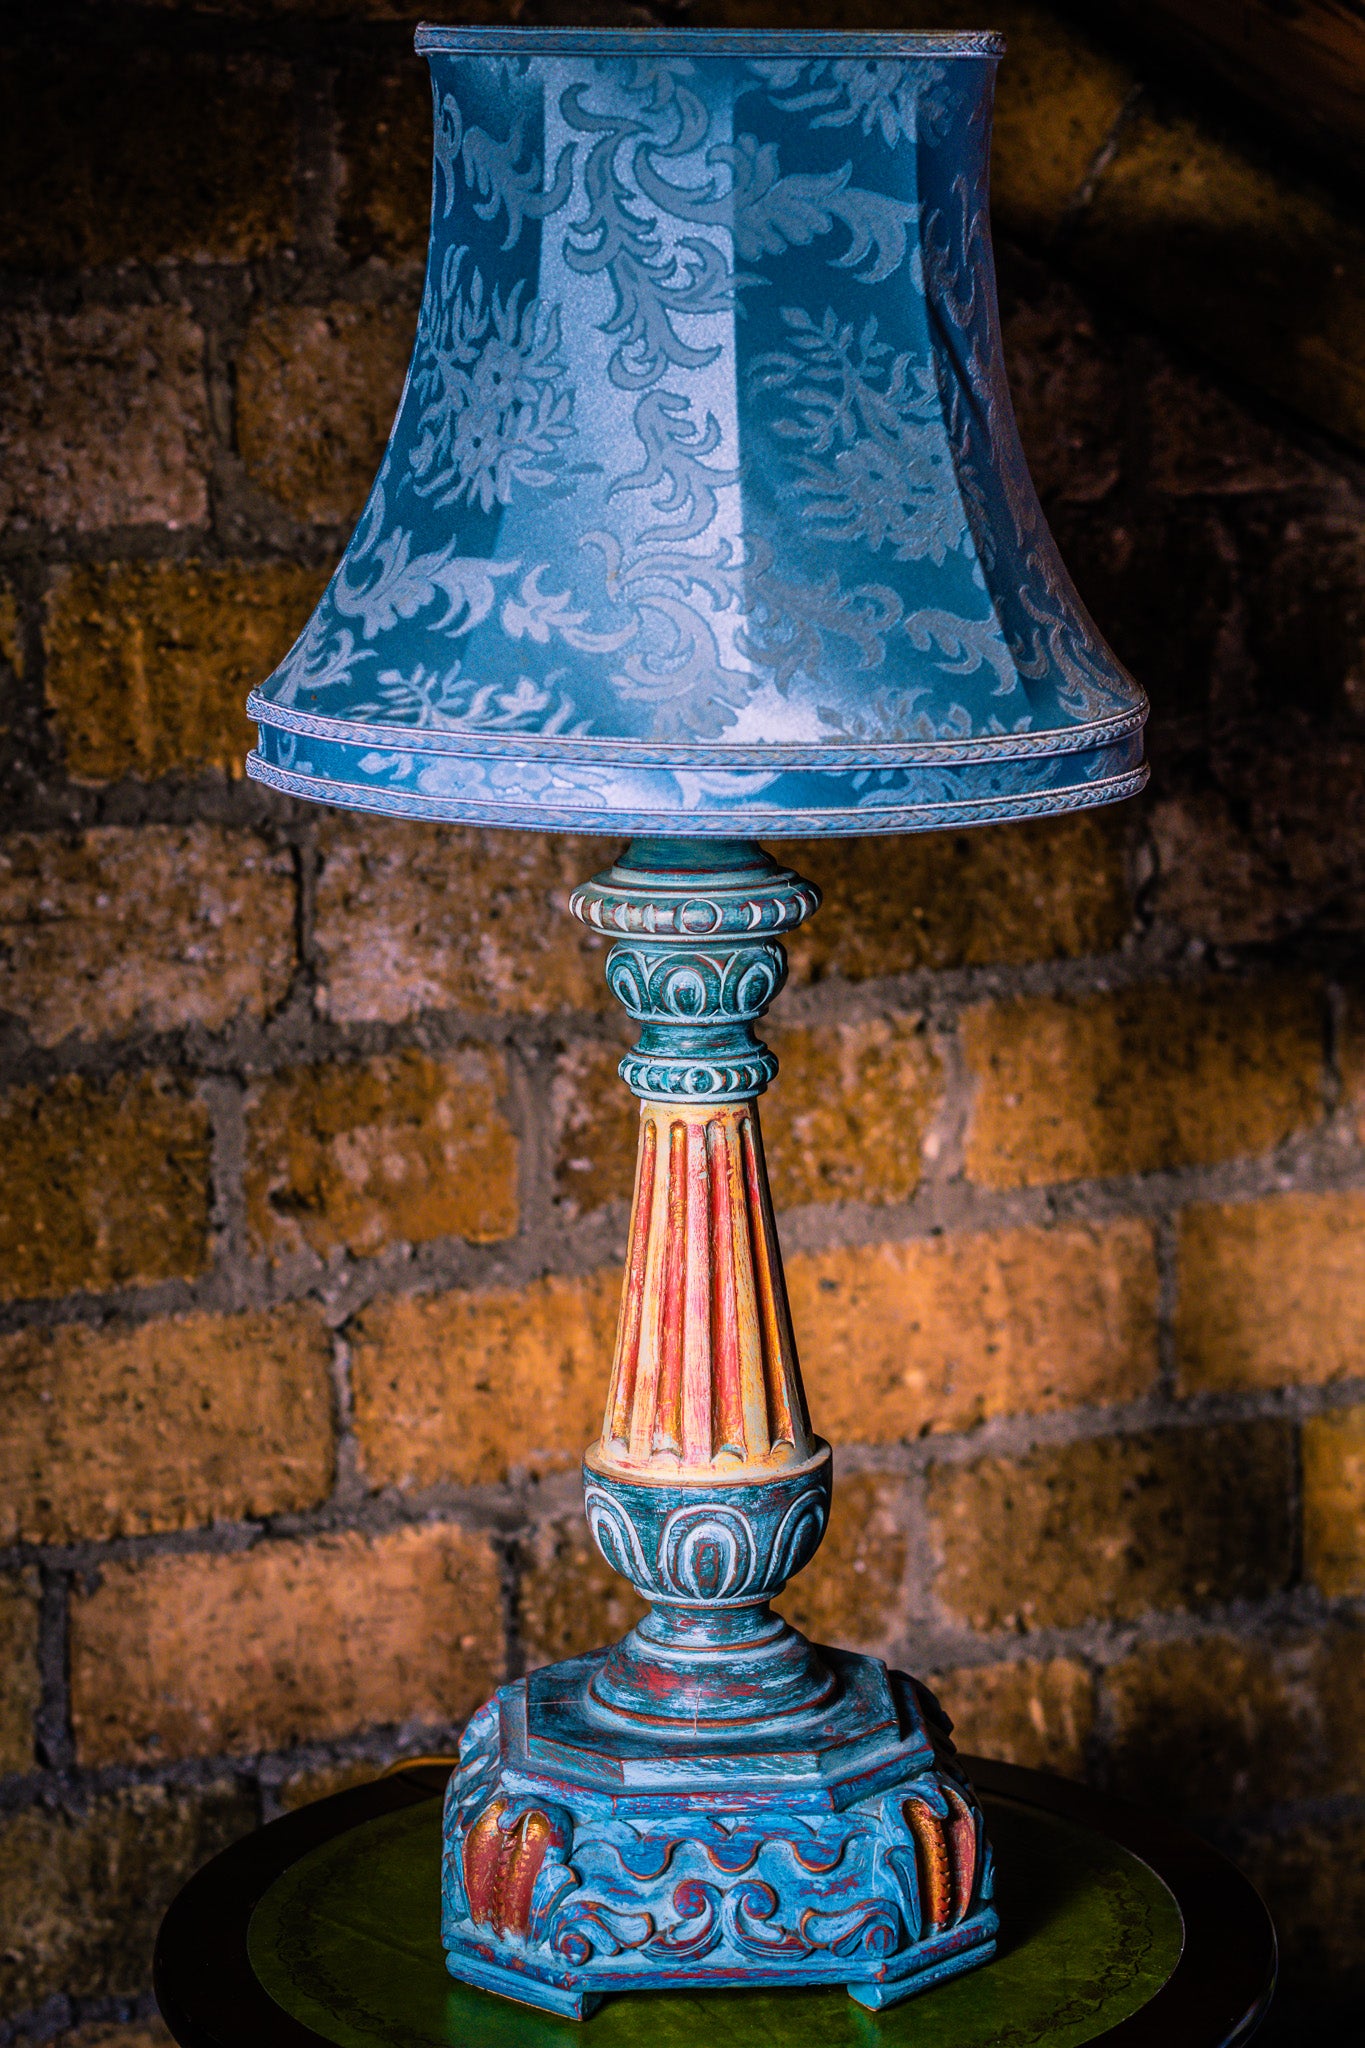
(237, 303, 415, 524)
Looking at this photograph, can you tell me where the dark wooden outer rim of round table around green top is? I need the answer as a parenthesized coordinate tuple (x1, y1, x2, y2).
(153, 1757, 1275, 2048)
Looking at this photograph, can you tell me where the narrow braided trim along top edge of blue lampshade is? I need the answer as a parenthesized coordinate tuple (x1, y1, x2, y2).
(413, 20, 1005, 59)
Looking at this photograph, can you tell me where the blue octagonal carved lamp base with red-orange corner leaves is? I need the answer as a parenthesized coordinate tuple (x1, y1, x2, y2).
(442, 1651, 997, 2017)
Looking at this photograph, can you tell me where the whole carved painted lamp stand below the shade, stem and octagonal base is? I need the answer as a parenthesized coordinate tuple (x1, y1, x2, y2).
(442, 840, 997, 2017)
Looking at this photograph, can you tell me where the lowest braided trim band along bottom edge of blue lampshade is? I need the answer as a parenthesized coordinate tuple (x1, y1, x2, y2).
(246, 752, 1150, 840)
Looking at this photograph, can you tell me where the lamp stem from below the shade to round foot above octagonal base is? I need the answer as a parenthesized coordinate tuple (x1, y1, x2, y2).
(571, 840, 833, 1737)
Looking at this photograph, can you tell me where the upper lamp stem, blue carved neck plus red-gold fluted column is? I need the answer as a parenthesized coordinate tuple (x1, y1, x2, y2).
(571, 840, 819, 1483)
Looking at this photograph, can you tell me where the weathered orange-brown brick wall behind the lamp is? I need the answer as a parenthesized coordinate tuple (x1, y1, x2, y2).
(0, 0, 1365, 2048)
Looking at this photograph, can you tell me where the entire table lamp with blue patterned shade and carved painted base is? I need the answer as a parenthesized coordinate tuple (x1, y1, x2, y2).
(248, 27, 1146, 2017)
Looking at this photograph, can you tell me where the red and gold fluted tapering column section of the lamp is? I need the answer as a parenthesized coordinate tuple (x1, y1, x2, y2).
(593, 1100, 814, 1479)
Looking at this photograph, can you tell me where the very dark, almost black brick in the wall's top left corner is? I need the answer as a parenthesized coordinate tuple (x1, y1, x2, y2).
(0, 37, 297, 270)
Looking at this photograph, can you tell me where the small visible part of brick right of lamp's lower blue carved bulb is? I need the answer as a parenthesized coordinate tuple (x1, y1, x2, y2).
(778, 1473, 907, 1649)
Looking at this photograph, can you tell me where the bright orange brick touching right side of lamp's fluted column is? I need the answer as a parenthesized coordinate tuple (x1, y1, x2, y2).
(788, 1221, 1156, 1444)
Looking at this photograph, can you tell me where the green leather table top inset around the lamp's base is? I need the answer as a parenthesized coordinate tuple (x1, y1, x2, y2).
(248, 1794, 1183, 2048)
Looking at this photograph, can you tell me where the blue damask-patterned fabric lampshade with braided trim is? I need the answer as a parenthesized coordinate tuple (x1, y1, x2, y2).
(248, 29, 1146, 838)
